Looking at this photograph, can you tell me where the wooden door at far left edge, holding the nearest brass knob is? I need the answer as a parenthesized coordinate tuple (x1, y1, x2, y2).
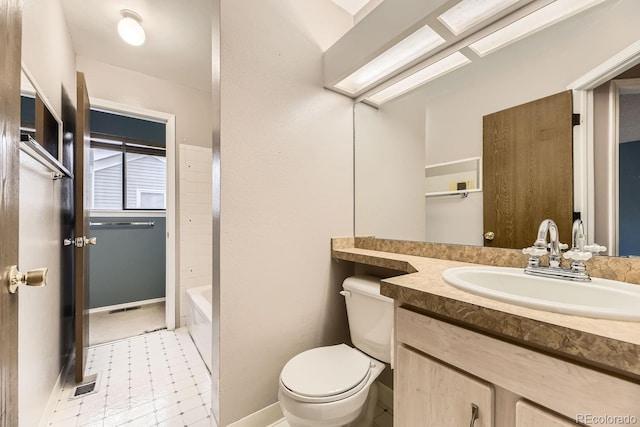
(0, 0, 22, 427)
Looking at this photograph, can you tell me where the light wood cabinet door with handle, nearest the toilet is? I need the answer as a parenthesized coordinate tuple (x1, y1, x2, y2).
(394, 346, 494, 427)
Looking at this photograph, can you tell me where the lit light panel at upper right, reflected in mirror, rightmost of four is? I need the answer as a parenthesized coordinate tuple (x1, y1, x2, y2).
(469, 0, 604, 56)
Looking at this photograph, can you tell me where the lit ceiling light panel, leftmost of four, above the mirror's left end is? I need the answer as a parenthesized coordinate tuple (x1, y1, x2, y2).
(336, 25, 445, 95)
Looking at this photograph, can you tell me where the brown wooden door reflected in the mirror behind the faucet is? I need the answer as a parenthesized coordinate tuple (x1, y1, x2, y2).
(482, 91, 573, 248)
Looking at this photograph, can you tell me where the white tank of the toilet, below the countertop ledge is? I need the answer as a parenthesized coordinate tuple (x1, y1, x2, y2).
(342, 276, 393, 363)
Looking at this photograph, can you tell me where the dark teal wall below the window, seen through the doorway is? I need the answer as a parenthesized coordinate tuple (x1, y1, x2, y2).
(89, 217, 166, 308)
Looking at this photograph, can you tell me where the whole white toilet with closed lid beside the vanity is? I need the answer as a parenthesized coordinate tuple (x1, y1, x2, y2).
(278, 276, 393, 427)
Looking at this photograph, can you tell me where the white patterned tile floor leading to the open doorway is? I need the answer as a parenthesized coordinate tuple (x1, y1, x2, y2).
(49, 329, 214, 427)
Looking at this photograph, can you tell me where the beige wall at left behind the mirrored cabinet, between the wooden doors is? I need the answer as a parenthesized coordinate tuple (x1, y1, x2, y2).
(18, 0, 76, 426)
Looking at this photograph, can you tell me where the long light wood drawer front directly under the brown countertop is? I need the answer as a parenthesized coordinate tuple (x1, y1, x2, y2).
(396, 308, 640, 425)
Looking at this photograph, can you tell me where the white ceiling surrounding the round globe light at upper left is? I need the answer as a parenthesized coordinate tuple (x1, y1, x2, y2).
(61, 0, 212, 91)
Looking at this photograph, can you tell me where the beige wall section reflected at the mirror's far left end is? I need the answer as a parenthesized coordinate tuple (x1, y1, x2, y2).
(354, 97, 425, 240)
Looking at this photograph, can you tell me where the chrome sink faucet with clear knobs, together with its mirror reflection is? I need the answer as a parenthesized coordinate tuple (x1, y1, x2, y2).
(522, 219, 607, 282)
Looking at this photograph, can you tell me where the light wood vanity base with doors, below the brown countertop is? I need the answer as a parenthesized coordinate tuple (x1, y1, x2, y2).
(394, 306, 640, 427)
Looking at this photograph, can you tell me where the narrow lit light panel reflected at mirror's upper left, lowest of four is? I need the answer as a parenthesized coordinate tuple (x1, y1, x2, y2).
(367, 52, 471, 105)
